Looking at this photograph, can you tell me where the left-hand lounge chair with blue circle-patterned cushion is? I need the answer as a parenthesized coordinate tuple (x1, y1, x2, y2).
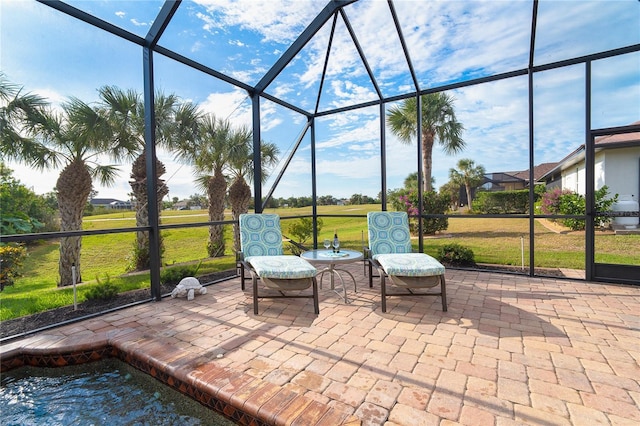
(238, 214, 320, 315)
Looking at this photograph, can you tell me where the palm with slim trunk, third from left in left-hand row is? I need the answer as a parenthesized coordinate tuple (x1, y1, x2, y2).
(176, 114, 233, 257)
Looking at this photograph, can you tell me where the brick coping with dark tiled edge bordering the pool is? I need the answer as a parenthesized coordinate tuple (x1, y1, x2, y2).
(0, 329, 361, 426)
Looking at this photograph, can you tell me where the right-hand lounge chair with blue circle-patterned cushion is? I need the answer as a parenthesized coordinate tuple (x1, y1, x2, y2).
(367, 212, 447, 312)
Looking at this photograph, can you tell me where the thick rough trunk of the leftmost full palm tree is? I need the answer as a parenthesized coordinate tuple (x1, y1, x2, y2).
(56, 160, 92, 287)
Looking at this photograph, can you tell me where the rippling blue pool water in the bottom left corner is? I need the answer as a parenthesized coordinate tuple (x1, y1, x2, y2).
(0, 359, 234, 426)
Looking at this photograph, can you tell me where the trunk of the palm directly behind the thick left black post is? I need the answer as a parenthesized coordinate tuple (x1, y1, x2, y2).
(129, 150, 169, 271)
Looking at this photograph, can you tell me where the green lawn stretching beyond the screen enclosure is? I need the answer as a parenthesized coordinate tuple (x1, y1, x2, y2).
(0, 205, 640, 321)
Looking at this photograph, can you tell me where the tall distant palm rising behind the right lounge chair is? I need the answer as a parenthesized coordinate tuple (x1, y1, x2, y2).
(387, 92, 465, 192)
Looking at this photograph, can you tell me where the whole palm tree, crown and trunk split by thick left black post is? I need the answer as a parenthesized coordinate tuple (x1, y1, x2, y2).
(99, 86, 198, 270)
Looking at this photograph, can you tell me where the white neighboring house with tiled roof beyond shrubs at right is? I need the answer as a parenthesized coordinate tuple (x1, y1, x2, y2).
(539, 121, 640, 201)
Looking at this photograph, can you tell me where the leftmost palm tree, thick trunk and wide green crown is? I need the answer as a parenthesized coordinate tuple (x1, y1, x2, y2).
(0, 76, 131, 286)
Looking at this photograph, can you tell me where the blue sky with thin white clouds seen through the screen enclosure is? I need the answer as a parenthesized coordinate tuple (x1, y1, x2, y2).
(0, 0, 640, 199)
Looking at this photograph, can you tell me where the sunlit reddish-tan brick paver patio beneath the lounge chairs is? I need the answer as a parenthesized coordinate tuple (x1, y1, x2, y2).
(1, 264, 640, 426)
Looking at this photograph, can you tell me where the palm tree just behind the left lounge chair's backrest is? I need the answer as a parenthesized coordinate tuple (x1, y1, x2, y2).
(229, 126, 279, 251)
